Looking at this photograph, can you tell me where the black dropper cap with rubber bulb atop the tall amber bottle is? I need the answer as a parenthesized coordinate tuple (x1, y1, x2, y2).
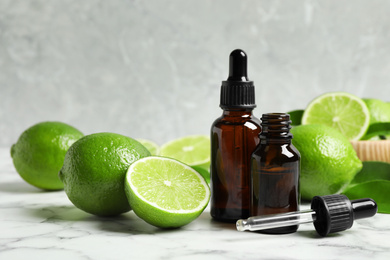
(219, 49, 256, 109)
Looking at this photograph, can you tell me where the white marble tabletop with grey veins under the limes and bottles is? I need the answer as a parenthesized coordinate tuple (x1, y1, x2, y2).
(0, 148, 390, 260)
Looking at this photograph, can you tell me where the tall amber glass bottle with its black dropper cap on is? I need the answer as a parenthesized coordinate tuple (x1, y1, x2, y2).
(210, 50, 261, 222)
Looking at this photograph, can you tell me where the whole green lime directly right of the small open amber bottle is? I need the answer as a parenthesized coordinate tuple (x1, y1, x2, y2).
(291, 125, 362, 200)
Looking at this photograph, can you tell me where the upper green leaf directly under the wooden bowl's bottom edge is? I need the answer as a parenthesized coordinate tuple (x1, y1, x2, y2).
(350, 162, 390, 185)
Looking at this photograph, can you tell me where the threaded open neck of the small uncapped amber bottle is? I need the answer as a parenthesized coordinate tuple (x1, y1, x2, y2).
(260, 113, 292, 144)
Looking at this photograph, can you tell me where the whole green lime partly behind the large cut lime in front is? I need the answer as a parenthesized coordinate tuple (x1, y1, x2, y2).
(59, 133, 150, 216)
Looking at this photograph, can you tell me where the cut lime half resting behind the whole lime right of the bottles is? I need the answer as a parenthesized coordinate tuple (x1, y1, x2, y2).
(302, 92, 370, 140)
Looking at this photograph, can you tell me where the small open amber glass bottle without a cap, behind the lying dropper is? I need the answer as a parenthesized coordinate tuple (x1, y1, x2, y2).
(251, 113, 300, 234)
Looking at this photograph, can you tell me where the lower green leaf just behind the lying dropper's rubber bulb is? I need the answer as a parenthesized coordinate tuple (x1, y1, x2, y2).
(343, 180, 390, 214)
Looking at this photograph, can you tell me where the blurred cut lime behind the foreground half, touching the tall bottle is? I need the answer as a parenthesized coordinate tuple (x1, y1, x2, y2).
(161, 135, 210, 168)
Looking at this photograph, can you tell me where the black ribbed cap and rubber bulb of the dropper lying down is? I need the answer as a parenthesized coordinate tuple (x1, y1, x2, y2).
(311, 194, 378, 237)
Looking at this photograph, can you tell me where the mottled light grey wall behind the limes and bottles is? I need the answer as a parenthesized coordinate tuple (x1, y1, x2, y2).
(0, 0, 390, 147)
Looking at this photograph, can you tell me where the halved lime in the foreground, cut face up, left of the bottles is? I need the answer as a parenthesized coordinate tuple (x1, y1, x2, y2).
(125, 156, 210, 228)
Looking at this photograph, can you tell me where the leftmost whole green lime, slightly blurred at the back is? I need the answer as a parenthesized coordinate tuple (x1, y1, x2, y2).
(11, 122, 83, 190)
